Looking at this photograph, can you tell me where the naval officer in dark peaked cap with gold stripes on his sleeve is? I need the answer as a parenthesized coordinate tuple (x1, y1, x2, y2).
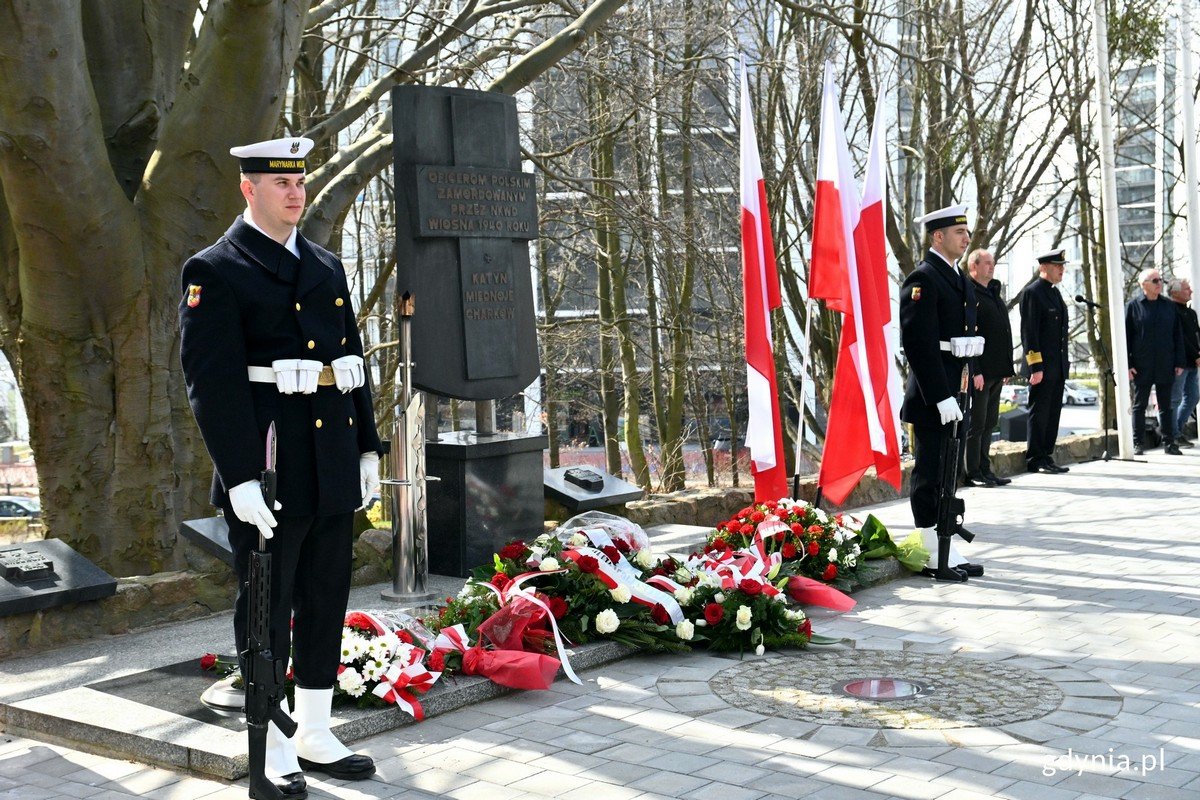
(1021, 249, 1070, 474)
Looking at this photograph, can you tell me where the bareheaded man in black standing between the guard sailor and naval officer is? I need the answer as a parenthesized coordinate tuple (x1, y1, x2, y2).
(964, 249, 1013, 486)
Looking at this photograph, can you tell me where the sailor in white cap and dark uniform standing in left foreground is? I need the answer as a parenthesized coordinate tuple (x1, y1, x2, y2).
(179, 138, 382, 798)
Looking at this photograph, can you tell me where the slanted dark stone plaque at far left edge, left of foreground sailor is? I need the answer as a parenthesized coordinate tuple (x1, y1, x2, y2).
(0, 539, 116, 616)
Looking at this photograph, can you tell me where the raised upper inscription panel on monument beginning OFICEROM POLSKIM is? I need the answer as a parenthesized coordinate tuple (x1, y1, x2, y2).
(416, 166, 538, 239)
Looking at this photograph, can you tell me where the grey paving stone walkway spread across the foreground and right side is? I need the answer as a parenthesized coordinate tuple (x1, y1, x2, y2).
(0, 451, 1200, 800)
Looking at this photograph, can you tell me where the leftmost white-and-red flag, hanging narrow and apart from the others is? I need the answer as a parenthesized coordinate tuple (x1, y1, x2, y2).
(740, 61, 787, 501)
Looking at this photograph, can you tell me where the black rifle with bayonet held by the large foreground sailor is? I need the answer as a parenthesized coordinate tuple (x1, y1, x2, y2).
(242, 422, 296, 800)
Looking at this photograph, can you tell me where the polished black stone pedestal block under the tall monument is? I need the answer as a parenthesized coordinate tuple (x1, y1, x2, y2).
(425, 431, 547, 578)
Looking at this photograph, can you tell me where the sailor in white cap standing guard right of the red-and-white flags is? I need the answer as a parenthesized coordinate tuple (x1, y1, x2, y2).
(900, 205, 983, 575)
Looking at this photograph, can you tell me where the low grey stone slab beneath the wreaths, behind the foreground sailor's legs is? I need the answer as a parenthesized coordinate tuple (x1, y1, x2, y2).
(0, 642, 632, 781)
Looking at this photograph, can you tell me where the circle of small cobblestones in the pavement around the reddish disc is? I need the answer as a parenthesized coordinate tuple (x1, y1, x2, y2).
(709, 650, 1063, 730)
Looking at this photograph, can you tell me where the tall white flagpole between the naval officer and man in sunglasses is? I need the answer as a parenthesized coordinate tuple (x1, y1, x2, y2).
(1092, 0, 1133, 458)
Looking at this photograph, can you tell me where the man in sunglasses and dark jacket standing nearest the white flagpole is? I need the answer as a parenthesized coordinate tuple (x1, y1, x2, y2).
(1126, 269, 1187, 456)
